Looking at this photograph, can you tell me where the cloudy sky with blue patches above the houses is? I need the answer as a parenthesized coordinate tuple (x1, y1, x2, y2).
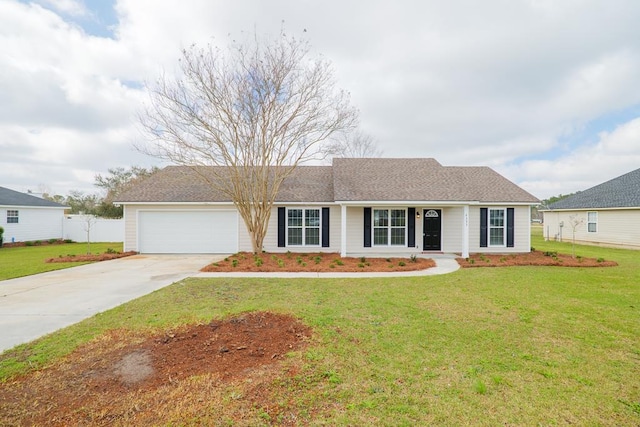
(0, 0, 640, 198)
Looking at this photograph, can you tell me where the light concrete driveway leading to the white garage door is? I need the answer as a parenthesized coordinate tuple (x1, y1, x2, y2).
(0, 254, 224, 352)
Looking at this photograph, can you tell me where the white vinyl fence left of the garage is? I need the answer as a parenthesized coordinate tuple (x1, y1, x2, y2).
(62, 215, 124, 242)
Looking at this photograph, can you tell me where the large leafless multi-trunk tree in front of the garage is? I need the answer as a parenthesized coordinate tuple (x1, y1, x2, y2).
(138, 32, 357, 252)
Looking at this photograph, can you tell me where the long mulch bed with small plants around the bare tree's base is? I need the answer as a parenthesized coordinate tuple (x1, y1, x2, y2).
(201, 252, 436, 273)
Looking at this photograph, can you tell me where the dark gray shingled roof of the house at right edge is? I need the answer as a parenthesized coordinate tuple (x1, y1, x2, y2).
(548, 169, 640, 210)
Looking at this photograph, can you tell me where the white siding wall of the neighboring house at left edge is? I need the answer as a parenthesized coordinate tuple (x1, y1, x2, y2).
(0, 206, 64, 243)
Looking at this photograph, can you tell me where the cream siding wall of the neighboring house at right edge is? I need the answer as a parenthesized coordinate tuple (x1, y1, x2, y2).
(543, 209, 640, 249)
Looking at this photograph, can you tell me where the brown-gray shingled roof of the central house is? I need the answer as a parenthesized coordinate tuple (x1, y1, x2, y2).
(117, 158, 538, 203)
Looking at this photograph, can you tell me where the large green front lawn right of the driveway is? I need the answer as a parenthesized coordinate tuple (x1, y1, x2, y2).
(0, 230, 640, 426)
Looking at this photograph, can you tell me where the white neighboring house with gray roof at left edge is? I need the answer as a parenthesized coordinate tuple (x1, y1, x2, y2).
(0, 187, 66, 243)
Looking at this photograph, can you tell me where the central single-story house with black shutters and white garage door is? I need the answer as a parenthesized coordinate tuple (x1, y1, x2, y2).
(115, 158, 539, 256)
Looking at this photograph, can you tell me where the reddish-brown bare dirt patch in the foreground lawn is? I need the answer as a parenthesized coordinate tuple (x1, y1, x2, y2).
(0, 312, 311, 426)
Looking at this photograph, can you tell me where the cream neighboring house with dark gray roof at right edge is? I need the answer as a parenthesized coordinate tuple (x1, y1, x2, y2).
(543, 169, 640, 249)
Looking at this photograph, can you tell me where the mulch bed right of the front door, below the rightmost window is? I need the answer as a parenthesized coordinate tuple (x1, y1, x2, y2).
(456, 251, 618, 268)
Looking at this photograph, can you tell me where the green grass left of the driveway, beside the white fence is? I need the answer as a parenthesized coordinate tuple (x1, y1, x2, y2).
(0, 243, 122, 280)
